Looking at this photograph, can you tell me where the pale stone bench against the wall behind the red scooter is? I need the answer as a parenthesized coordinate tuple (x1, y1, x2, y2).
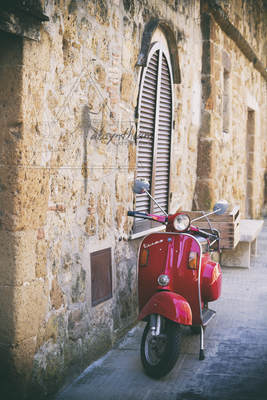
(220, 219, 264, 268)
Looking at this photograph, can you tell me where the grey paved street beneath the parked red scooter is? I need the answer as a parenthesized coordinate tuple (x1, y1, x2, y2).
(56, 227, 267, 400)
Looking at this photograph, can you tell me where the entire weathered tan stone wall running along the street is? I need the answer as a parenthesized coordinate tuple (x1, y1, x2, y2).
(0, 0, 266, 399)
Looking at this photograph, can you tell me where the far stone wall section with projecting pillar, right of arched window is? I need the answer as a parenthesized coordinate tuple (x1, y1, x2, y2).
(194, 1, 267, 218)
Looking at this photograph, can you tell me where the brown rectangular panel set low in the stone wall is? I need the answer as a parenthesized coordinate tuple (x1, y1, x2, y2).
(90, 248, 112, 307)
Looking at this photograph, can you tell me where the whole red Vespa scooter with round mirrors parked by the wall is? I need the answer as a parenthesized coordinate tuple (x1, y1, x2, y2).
(128, 179, 228, 378)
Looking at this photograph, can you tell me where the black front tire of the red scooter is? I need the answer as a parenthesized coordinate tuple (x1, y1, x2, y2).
(141, 318, 182, 378)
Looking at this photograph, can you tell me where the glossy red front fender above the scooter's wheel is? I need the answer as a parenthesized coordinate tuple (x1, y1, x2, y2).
(138, 291, 192, 325)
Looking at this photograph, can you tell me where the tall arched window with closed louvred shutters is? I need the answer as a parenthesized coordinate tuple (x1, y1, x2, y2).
(133, 42, 173, 233)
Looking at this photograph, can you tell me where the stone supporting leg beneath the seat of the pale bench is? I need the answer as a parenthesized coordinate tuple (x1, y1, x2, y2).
(220, 242, 251, 268)
